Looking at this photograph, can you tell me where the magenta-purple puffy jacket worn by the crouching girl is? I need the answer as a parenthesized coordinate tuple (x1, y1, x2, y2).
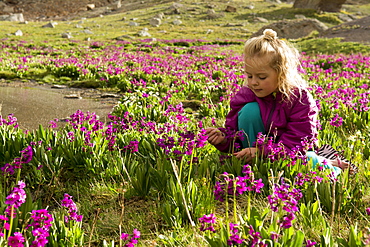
(215, 86, 318, 152)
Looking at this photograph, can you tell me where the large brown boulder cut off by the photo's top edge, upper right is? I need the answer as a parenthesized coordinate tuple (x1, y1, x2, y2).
(293, 0, 346, 12)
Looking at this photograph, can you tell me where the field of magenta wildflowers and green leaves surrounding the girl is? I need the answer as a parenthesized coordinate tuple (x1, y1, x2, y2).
(0, 37, 370, 247)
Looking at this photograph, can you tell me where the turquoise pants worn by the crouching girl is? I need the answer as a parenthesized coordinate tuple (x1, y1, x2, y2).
(238, 102, 342, 177)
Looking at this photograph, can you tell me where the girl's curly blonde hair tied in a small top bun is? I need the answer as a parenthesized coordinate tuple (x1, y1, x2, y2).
(243, 29, 307, 101)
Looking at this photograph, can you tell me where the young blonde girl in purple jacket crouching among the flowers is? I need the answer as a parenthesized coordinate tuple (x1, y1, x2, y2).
(206, 29, 348, 175)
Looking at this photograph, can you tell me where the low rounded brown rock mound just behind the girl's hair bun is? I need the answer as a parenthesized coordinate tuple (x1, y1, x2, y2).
(252, 18, 328, 39)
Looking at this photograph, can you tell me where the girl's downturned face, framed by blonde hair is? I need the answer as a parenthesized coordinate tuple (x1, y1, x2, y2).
(245, 57, 278, 98)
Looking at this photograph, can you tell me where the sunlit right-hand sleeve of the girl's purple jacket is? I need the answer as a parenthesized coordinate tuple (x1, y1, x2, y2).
(268, 91, 318, 152)
